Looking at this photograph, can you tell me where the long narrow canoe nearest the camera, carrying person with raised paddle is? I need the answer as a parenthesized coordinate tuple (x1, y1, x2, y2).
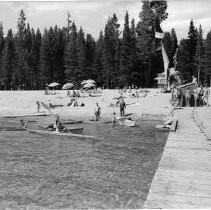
(27, 129, 97, 140)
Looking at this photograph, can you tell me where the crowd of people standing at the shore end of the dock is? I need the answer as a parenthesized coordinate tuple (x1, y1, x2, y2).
(172, 84, 210, 107)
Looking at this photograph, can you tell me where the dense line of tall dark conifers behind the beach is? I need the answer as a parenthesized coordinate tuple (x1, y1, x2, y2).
(0, 1, 211, 90)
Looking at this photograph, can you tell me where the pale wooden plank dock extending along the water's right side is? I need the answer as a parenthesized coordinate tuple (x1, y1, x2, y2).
(144, 107, 211, 209)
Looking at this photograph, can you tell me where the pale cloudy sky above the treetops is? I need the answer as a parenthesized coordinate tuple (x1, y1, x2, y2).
(0, 0, 211, 39)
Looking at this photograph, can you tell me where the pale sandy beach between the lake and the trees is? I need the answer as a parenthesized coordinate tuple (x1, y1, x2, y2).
(0, 89, 172, 119)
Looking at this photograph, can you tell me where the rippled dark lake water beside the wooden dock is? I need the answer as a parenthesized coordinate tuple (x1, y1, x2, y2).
(0, 117, 168, 209)
